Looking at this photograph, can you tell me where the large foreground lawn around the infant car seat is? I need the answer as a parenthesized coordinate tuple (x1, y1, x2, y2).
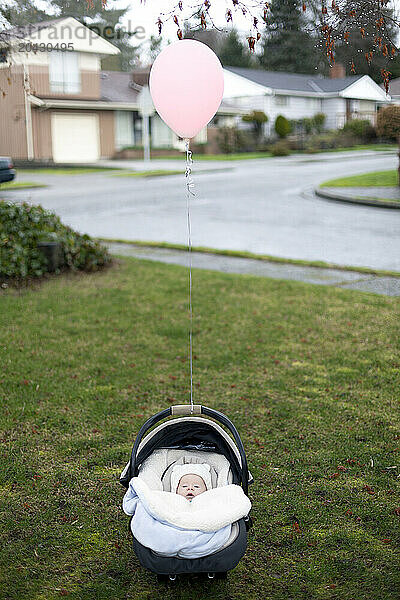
(0, 259, 400, 600)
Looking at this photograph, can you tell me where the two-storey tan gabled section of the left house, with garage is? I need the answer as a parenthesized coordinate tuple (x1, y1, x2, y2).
(0, 17, 127, 162)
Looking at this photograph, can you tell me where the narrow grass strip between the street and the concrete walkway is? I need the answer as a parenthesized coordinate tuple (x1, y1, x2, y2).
(96, 237, 400, 277)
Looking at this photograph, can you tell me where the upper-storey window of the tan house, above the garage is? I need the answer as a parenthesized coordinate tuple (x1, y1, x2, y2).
(49, 51, 81, 94)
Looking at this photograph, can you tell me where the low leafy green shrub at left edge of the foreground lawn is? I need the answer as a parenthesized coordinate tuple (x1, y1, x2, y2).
(0, 201, 111, 278)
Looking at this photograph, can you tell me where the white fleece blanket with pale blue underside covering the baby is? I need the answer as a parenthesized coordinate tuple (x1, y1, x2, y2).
(122, 477, 251, 558)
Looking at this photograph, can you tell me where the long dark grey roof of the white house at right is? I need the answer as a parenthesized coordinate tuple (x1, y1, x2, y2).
(225, 67, 363, 94)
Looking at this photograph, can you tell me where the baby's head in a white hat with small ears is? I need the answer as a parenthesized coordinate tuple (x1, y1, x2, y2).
(171, 463, 212, 502)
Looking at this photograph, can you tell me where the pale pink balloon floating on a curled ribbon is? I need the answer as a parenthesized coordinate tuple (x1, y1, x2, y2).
(149, 40, 224, 138)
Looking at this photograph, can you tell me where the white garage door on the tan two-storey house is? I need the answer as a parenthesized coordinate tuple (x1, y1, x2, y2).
(51, 113, 100, 163)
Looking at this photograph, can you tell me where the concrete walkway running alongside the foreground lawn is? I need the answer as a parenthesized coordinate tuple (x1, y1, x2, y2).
(105, 243, 400, 296)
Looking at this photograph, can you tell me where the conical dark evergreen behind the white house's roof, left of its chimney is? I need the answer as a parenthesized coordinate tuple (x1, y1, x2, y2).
(259, 0, 328, 74)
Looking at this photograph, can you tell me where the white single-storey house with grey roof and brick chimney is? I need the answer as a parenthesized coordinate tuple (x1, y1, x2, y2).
(224, 65, 390, 135)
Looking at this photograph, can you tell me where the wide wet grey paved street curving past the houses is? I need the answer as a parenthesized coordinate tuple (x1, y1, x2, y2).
(1, 152, 400, 271)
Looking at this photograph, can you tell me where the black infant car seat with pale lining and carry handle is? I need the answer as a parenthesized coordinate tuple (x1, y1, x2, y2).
(120, 404, 253, 580)
